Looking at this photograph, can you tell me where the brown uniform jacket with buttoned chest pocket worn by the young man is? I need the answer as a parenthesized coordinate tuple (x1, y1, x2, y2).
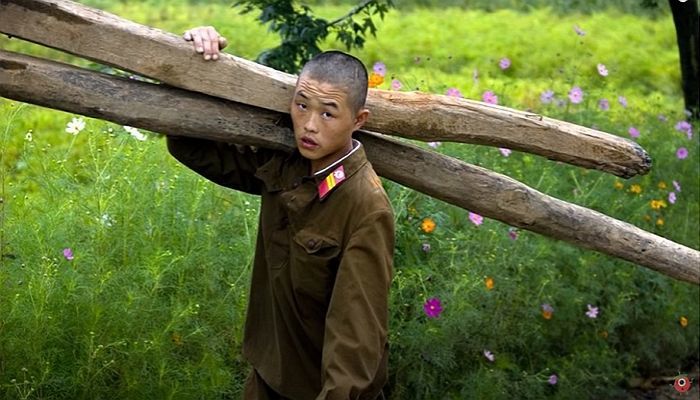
(168, 137, 394, 400)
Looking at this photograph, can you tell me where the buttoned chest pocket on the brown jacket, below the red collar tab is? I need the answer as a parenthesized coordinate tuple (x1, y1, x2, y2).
(290, 230, 341, 304)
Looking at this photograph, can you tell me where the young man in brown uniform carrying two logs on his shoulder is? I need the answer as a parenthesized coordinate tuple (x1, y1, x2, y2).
(168, 27, 394, 400)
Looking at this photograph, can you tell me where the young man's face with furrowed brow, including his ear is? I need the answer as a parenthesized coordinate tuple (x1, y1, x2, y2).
(290, 74, 369, 173)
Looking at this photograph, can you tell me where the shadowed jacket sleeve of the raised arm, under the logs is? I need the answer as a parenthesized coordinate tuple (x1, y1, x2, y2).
(167, 136, 273, 194)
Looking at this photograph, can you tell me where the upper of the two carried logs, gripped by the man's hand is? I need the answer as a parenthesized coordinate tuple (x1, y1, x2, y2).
(0, 0, 651, 178)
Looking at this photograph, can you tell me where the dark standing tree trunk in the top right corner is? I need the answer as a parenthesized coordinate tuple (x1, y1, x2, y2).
(668, 0, 700, 119)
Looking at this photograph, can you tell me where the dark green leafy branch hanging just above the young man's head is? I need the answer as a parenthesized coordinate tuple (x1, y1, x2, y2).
(234, 0, 392, 73)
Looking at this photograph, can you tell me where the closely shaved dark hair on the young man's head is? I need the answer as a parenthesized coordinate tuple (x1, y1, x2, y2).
(299, 51, 367, 112)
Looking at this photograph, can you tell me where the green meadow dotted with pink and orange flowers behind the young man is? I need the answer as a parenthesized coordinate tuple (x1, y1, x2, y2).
(0, 0, 700, 399)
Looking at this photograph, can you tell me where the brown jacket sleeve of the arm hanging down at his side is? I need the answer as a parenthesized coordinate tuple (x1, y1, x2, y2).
(316, 210, 394, 400)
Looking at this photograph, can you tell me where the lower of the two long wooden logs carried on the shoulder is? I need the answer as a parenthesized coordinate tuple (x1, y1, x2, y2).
(0, 51, 700, 285)
